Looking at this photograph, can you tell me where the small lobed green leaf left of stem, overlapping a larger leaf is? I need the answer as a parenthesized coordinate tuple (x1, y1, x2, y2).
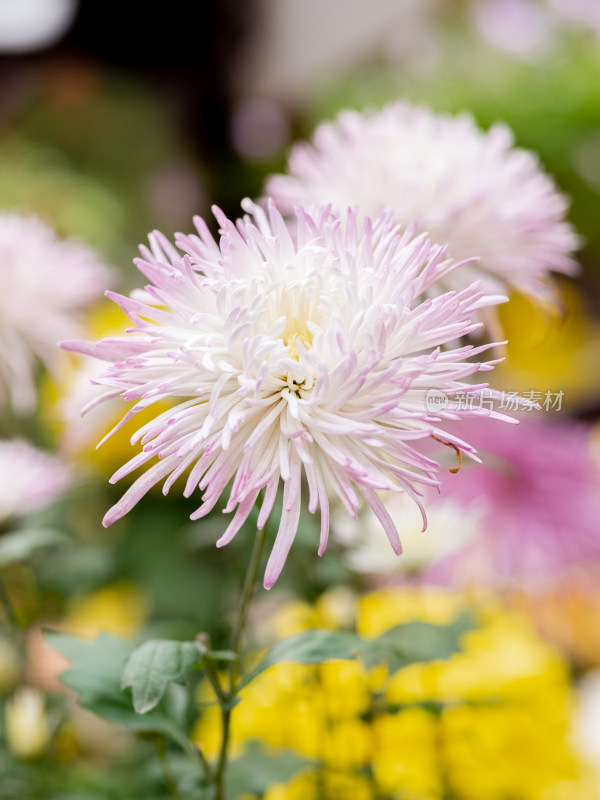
(121, 639, 202, 714)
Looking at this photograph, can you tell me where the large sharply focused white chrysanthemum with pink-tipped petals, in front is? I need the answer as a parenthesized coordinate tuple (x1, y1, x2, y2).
(63, 201, 520, 587)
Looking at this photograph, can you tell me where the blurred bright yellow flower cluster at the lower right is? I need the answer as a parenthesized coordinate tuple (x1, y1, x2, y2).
(196, 589, 600, 800)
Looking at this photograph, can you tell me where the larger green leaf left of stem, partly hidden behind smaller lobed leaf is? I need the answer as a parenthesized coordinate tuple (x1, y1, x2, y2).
(46, 631, 196, 758)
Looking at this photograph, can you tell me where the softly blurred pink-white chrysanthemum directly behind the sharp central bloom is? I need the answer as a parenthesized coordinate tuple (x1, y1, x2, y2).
(266, 103, 578, 299)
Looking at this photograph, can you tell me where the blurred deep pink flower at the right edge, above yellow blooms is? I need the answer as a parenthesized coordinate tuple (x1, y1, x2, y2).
(431, 418, 600, 589)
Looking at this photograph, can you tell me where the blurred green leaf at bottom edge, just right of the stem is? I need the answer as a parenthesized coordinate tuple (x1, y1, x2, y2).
(225, 742, 314, 797)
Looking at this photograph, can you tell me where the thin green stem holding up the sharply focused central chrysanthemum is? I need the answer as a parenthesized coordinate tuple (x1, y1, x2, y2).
(209, 525, 267, 800)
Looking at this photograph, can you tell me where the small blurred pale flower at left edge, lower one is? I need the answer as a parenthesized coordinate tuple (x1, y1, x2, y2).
(0, 439, 72, 523)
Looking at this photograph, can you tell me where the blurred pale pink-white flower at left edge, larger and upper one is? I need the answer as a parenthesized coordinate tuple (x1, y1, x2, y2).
(0, 213, 110, 413)
